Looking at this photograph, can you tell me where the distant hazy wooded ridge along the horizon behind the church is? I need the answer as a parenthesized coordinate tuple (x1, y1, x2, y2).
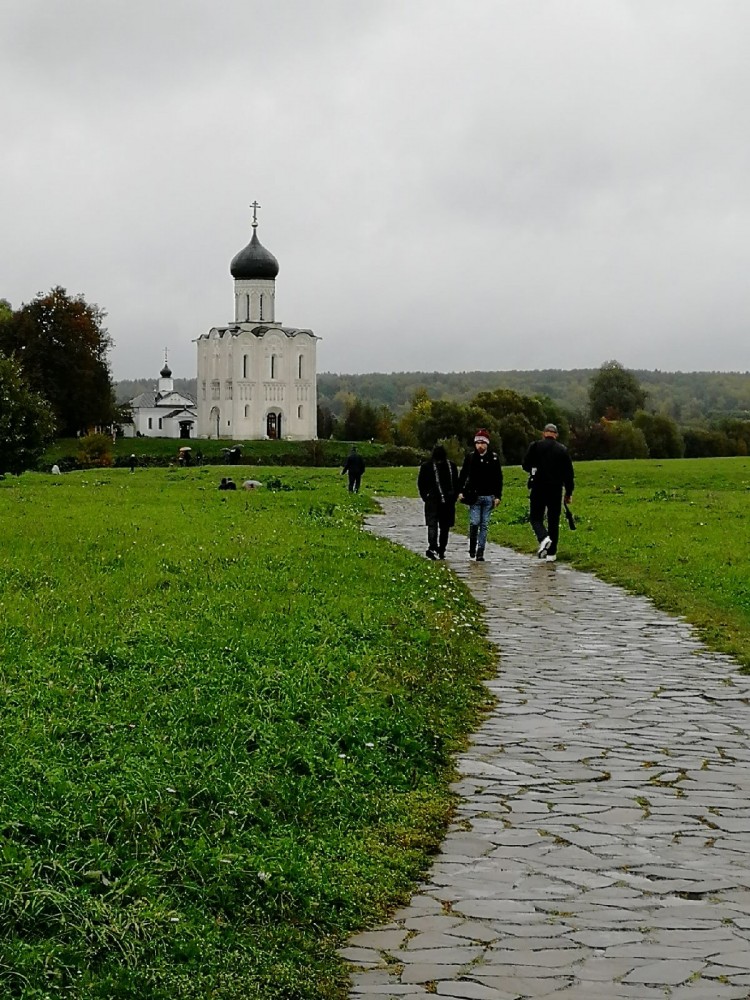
(116, 368, 750, 425)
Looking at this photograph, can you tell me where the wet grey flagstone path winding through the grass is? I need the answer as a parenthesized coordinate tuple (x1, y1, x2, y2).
(342, 500, 750, 1000)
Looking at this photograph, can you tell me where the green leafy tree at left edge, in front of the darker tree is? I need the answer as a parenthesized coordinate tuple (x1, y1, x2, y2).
(0, 354, 55, 474)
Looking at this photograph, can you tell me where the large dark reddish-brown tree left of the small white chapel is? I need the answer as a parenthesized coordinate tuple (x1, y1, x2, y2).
(0, 286, 115, 437)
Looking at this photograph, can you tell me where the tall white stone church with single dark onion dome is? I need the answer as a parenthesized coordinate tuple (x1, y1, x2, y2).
(196, 202, 320, 441)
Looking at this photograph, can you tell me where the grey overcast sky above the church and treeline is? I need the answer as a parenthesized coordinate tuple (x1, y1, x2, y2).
(0, 0, 750, 379)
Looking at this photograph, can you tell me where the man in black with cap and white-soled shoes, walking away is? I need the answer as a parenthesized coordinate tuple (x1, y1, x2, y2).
(522, 424, 575, 562)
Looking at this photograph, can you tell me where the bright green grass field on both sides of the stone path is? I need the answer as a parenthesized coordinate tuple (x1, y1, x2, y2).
(0, 459, 750, 1000)
